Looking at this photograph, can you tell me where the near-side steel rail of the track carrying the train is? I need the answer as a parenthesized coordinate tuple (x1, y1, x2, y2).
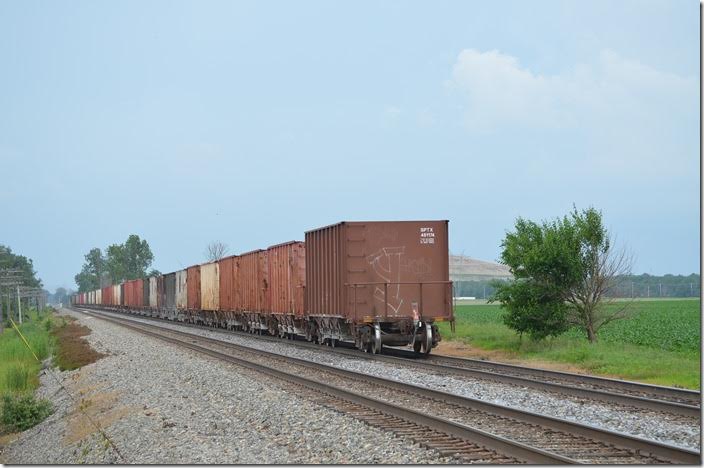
(75, 306, 701, 419)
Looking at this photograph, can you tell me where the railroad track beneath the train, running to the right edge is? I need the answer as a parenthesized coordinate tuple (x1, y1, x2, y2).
(81, 306, 701, 421)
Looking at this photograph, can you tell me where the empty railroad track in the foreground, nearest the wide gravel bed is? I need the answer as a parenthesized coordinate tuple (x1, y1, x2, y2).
(71, 312, 700, 464)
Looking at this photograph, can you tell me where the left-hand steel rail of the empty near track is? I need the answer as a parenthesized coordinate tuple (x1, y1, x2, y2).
(75, 311, 578, 464)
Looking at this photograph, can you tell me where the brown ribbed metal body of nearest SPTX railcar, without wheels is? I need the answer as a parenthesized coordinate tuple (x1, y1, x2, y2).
(306, 221, 452, 321)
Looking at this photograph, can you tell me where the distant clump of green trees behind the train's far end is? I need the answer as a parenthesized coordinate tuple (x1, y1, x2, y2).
(74, 234, 161, 292)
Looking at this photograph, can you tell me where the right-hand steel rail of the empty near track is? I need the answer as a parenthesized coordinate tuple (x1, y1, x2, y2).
(73, 308, 701, 464)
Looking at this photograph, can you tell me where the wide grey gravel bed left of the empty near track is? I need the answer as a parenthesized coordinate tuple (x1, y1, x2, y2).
(0, 312, 452, 464)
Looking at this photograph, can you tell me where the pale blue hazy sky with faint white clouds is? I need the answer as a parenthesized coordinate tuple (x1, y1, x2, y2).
(0, 0, 700, 290)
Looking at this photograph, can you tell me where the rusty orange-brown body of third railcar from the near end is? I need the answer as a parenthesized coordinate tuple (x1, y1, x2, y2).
(235, 250, 269, 312)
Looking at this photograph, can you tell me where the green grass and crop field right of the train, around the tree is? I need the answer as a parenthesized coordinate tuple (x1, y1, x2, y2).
(439, 299, 701, 389)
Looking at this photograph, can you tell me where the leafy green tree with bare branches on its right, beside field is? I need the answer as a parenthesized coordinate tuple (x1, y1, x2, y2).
(492, 208, 631, 342)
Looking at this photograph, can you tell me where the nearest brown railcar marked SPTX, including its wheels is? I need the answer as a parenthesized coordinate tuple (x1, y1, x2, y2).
(306, 221, 453, 353)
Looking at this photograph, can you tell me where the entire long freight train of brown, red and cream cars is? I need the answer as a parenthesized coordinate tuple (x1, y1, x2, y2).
(72, 221, 454, 354)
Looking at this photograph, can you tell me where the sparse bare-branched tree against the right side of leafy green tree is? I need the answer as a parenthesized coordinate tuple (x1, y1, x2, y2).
(567, 240, 633, 343)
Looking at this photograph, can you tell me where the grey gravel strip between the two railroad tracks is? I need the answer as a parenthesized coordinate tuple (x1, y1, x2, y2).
(91, 314, 700, 450)
